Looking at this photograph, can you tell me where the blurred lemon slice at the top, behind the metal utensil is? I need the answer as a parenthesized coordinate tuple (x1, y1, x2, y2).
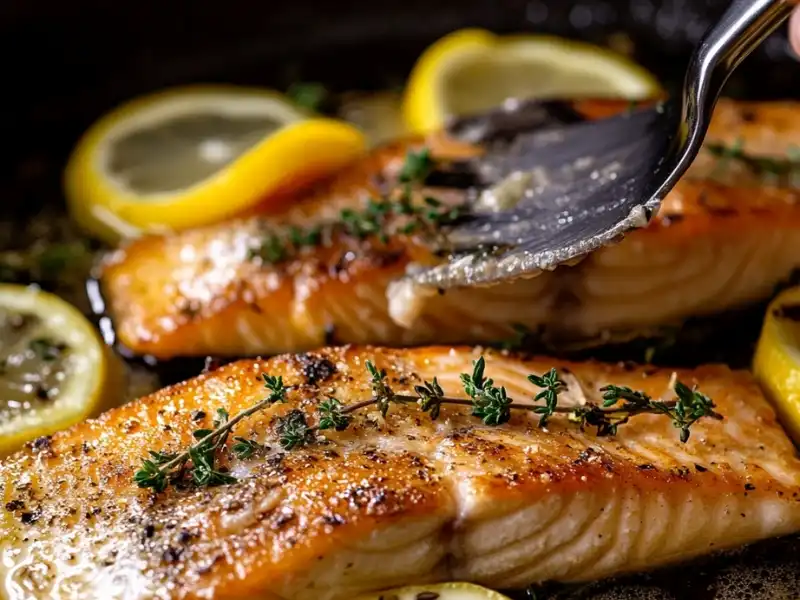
(403, 29, 660, 132)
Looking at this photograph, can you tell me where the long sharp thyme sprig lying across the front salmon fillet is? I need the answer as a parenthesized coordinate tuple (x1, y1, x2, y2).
(134, 356, 722, 492)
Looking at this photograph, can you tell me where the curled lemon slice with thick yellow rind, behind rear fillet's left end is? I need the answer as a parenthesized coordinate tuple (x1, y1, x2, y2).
(65, 86, 366, 242)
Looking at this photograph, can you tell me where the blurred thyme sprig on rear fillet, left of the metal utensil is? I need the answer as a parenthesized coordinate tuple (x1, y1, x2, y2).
(248, 148, 463, 264)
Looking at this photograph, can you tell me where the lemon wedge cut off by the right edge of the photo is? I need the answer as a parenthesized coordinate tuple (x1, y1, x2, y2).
(753, 287, 800, 443)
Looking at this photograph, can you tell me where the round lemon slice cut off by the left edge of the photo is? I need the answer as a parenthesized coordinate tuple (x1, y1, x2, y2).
(0, 285, 115, 455)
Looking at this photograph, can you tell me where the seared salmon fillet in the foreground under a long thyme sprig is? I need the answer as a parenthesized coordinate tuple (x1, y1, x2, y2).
(0, 347, 800, 600)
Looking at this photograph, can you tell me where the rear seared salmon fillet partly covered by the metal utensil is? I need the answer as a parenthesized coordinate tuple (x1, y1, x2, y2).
(102, 102, 800, 358)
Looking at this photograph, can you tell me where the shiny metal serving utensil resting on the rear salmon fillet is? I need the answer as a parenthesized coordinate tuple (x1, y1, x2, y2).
(410, 0, 797, 290)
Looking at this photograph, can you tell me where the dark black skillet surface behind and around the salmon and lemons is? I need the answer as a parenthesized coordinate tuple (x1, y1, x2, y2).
(0, 0, 800, 600)
